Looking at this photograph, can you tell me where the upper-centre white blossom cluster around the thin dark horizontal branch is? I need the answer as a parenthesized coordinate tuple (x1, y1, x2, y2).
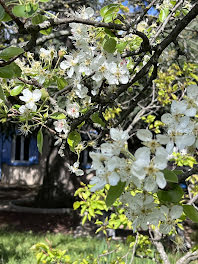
(60, 7, 129, 99)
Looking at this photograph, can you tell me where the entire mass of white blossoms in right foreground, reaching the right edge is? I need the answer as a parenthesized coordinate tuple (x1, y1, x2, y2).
(90, 85, 198, 234)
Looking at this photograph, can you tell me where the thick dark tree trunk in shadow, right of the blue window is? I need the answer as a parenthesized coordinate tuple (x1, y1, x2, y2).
(34, 134, 80, 208)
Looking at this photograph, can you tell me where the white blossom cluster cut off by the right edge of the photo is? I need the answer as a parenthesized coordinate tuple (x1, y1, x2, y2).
(157, 85, 198, 154)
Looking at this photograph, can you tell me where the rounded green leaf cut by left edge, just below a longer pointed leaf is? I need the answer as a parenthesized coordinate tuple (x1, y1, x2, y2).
(0, 62, 21, 78)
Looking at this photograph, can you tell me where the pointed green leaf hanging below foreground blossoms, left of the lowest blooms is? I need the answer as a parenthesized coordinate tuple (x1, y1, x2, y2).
(105, 181, 126, 207)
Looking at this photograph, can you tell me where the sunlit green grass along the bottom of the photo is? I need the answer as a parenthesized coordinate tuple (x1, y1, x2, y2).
(0, 229, 195, 264)
